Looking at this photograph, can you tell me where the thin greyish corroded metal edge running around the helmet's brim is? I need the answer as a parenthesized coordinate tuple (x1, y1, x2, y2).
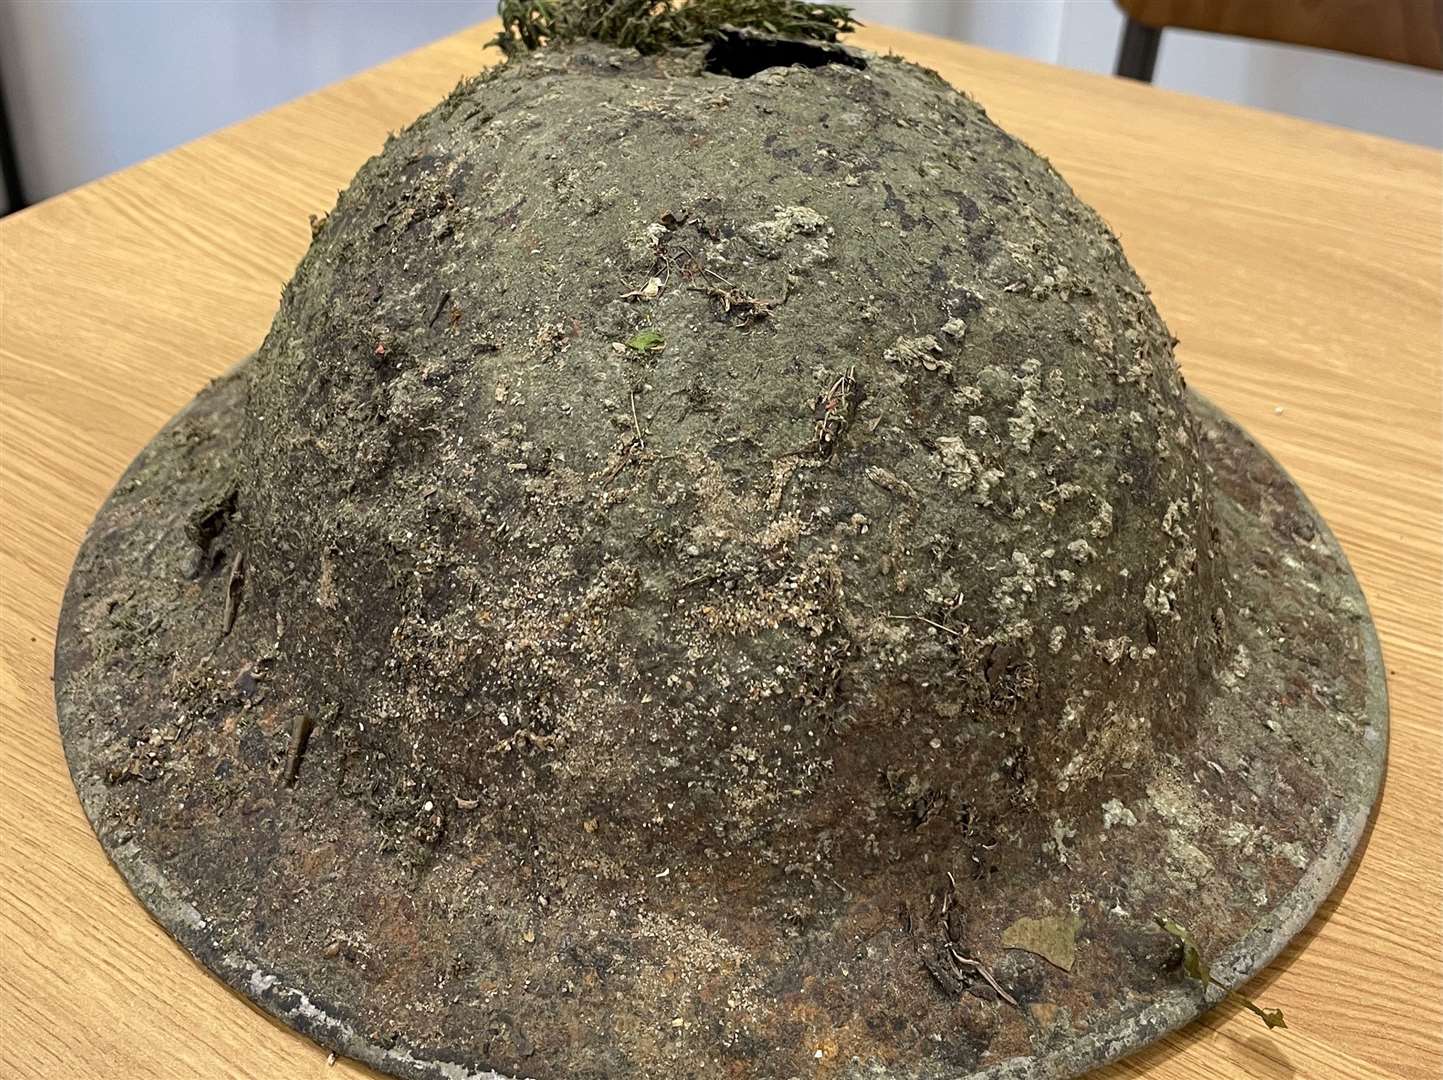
(56, 365, 1388, 1080)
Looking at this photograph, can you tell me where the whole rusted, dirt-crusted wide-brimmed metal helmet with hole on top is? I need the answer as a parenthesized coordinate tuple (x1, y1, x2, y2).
(56, 10, 1387, 1080)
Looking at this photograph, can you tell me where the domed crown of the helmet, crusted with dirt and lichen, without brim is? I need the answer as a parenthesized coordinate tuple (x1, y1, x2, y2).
(245, 37, 1224, 876)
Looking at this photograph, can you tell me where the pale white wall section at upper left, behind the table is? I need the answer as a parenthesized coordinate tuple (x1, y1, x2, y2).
(0, 0, 479, 202)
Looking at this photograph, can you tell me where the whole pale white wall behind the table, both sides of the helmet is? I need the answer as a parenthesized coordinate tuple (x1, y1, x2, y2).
(0, 0, 1443, 209)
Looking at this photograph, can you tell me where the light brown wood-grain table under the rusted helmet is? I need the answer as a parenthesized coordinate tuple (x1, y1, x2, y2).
(0, 16, 1443, 1080)
